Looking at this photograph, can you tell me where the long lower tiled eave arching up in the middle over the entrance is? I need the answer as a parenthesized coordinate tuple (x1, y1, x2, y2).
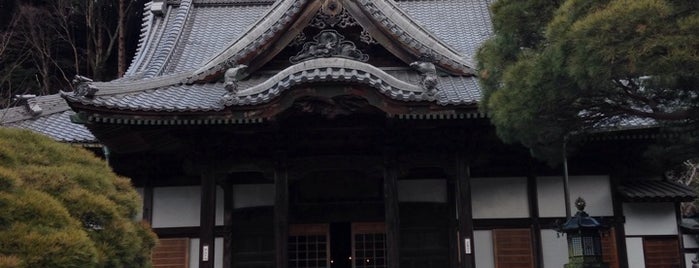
(62, 58, 477, 113)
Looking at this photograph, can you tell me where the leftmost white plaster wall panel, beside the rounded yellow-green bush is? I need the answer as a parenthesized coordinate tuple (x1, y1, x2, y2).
(153, 186, 201, 228)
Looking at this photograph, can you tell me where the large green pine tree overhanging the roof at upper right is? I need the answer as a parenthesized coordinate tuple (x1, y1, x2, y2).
(477, 0, 699, 162)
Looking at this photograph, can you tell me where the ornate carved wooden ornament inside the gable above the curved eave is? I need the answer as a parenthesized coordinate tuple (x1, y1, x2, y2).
(289, 30, 369, 64)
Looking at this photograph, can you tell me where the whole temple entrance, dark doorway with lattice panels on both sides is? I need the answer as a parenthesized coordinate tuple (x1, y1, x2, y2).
(288, 222, 386, 268)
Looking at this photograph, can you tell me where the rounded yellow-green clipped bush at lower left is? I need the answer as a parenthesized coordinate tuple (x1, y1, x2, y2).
(0, 128, 156, 267)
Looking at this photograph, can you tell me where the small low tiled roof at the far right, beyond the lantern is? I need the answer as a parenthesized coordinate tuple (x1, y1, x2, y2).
(617, 180, 697, 202)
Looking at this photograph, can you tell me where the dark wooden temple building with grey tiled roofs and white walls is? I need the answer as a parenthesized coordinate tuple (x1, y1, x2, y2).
(0, 0, 699, 268)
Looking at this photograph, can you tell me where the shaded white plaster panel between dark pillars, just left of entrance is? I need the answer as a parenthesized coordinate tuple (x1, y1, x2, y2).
(233, 184, 274, 208)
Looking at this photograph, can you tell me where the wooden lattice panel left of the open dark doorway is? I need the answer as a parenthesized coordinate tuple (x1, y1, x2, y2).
(288, 224, 330, 268)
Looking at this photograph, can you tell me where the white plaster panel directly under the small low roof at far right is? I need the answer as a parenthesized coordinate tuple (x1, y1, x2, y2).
(623, 203, 677, 235)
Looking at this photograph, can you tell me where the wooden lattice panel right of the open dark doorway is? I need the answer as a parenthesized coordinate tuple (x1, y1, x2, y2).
(352, 223, 388, 268)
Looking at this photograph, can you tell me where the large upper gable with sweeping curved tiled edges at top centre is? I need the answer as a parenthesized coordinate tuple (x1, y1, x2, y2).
(183, 0, 474, 84)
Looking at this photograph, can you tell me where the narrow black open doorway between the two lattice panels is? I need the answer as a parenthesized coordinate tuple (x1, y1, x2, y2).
(330, 222, 352, 268)
